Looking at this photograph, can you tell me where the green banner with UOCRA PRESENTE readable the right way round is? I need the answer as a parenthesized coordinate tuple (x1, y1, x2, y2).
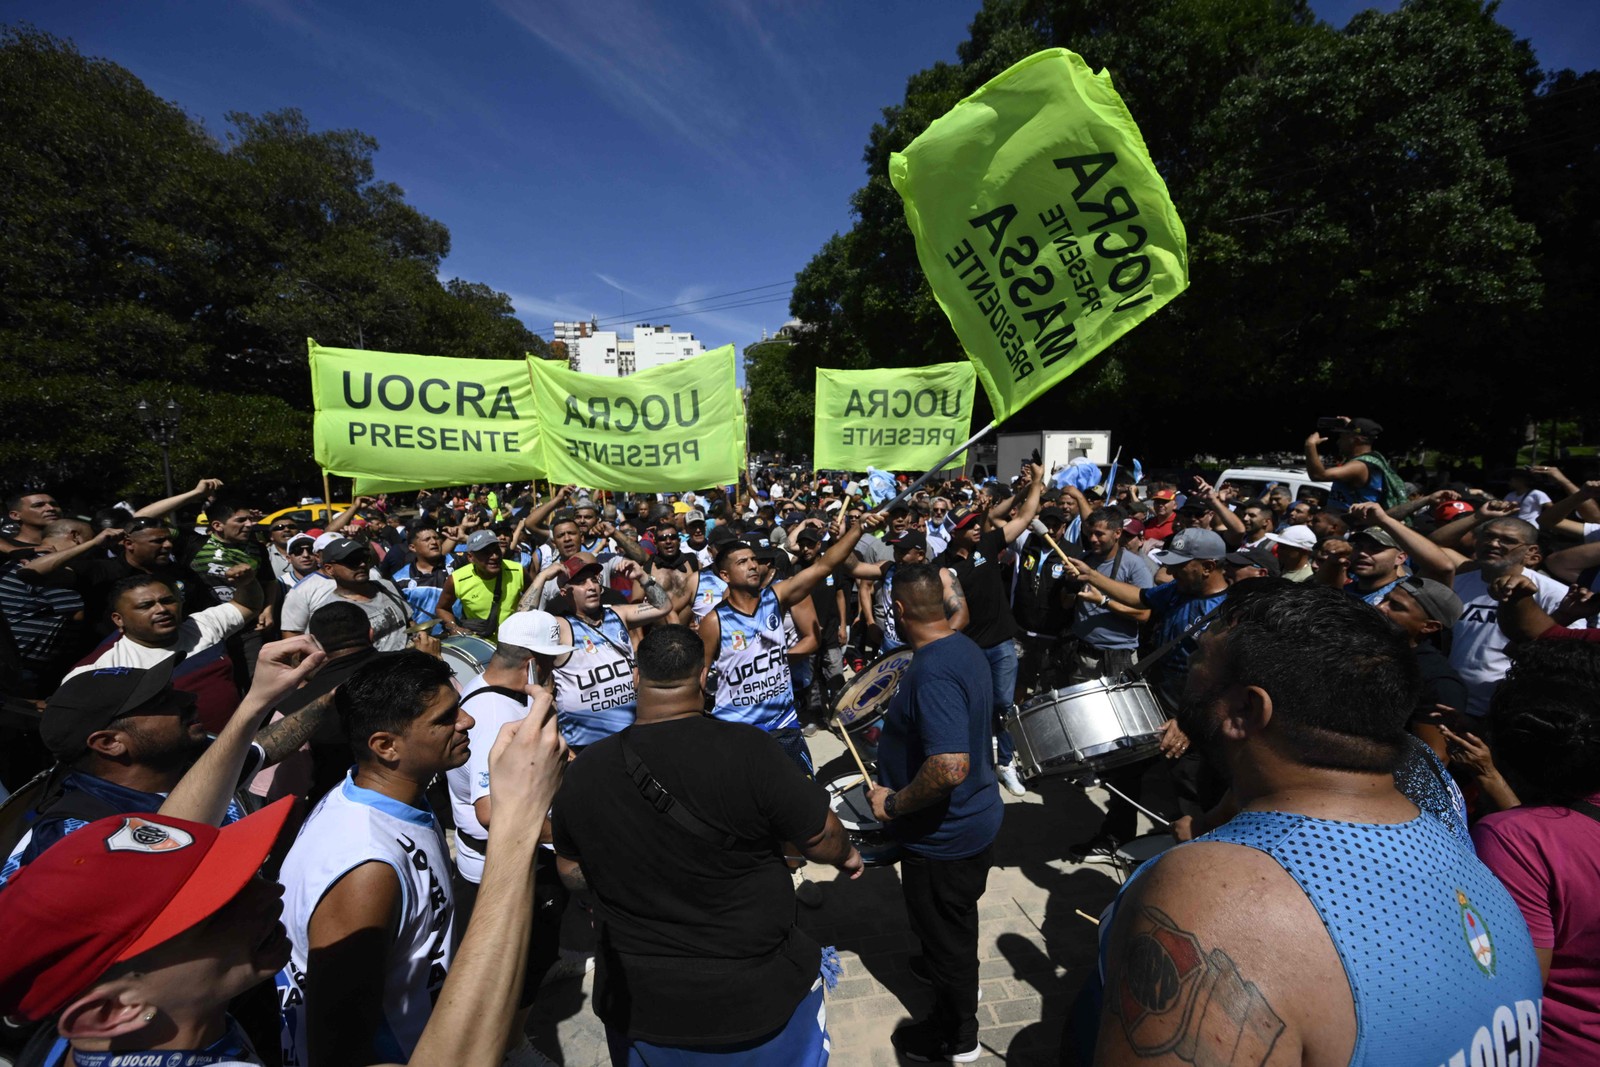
(309, 341, 539, 488)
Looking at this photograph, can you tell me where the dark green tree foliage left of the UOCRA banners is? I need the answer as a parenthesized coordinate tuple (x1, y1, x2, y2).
(0, 29, 544, 499)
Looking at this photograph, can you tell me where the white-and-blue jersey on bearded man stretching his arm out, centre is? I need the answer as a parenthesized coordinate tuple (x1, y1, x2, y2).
(712, 589, 798, 729)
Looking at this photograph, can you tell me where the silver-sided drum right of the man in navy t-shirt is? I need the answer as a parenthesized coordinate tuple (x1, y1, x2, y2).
(1006, 678, 1170, 777)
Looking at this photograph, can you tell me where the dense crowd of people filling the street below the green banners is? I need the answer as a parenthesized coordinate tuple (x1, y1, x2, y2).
(0, 419, 1600, 1067)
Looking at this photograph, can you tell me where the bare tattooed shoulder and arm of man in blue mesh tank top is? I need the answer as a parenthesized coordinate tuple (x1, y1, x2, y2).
(1094, 841, 1355, 1067)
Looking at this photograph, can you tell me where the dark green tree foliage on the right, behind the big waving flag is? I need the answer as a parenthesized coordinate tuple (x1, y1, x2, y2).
(780, 0, 1600, 461)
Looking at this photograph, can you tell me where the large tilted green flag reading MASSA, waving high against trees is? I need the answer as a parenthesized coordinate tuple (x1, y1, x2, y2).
(890, 48, 1189, 422)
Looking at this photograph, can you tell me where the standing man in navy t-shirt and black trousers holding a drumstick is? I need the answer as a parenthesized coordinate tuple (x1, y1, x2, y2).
(870, 565, 1005, 1062)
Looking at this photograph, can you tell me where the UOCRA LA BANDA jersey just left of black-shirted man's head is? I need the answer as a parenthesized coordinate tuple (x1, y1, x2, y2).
(554, 608, 637, 745)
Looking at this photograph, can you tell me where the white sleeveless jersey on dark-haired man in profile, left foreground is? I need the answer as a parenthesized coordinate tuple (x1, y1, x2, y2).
(277, 777, 456, 1067)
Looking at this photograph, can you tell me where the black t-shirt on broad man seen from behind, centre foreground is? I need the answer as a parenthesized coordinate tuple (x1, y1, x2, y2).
(552, 717, 827, 1045)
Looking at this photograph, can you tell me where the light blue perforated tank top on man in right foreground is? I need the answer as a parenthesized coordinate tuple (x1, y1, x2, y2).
(1102, 811, 1544, 1067)
